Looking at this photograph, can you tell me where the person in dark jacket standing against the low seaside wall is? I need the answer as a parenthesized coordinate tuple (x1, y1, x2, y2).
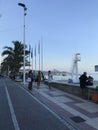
(79, 72, 88, 98)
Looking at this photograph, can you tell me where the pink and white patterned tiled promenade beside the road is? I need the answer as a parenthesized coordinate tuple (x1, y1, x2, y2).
(23, 83, 98, 130)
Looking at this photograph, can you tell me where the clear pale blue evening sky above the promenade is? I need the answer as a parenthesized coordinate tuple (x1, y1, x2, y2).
(0, 0, 98, 72)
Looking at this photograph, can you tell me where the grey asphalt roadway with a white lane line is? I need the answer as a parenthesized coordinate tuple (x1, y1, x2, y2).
(0, 78, 68, 130)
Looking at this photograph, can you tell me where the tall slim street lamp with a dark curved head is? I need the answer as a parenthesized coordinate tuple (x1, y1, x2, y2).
(18, 3, 27, 84)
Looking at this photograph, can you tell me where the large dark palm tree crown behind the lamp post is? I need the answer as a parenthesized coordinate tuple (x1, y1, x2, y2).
(2, 41, 30, 73)
